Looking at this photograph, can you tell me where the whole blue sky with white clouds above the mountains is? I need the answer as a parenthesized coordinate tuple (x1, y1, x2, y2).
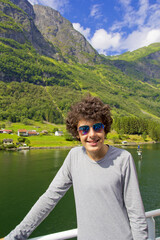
(29, 0, 160, 56)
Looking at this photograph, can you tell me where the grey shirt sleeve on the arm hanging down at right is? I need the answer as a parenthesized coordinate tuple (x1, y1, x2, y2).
(124, 155, 148, 240)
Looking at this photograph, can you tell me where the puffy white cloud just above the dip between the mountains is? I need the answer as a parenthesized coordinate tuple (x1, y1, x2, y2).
(90, 29, 121, 53)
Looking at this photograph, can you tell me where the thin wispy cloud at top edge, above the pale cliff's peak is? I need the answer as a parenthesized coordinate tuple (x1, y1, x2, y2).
(28, 0, 69, 13)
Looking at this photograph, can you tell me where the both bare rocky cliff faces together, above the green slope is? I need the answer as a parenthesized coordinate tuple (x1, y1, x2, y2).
(0, 0, 101, 64)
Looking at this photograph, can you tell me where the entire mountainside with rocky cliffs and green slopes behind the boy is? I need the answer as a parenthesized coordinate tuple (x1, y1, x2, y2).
(0, 0, 160, 123)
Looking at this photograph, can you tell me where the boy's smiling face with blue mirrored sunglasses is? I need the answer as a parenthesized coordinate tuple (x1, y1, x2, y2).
(77, 119, 107, 161)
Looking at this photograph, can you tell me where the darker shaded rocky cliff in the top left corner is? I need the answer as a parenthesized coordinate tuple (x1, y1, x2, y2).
(0, 0, 58, 59)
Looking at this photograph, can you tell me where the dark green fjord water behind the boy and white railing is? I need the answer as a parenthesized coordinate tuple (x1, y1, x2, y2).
(0, 144, 160, 237)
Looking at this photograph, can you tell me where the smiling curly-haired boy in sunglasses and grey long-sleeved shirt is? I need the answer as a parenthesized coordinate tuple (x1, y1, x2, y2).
(0, 96, 147, 240)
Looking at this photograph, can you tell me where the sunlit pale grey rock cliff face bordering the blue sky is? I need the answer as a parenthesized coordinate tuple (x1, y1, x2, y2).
(33, 5, 100, 63)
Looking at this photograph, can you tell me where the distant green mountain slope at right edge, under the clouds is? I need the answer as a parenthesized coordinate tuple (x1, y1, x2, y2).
(102, 43, 160, 88)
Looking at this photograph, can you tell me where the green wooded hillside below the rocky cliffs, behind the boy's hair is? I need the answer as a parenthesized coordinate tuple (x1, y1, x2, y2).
(0, 38, 160, 122)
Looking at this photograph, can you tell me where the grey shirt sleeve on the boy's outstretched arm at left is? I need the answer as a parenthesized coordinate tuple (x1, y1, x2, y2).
(5, 154, 72, 240)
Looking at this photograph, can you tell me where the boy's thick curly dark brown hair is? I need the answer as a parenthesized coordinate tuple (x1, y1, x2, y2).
(66, 95, 113, 139)
